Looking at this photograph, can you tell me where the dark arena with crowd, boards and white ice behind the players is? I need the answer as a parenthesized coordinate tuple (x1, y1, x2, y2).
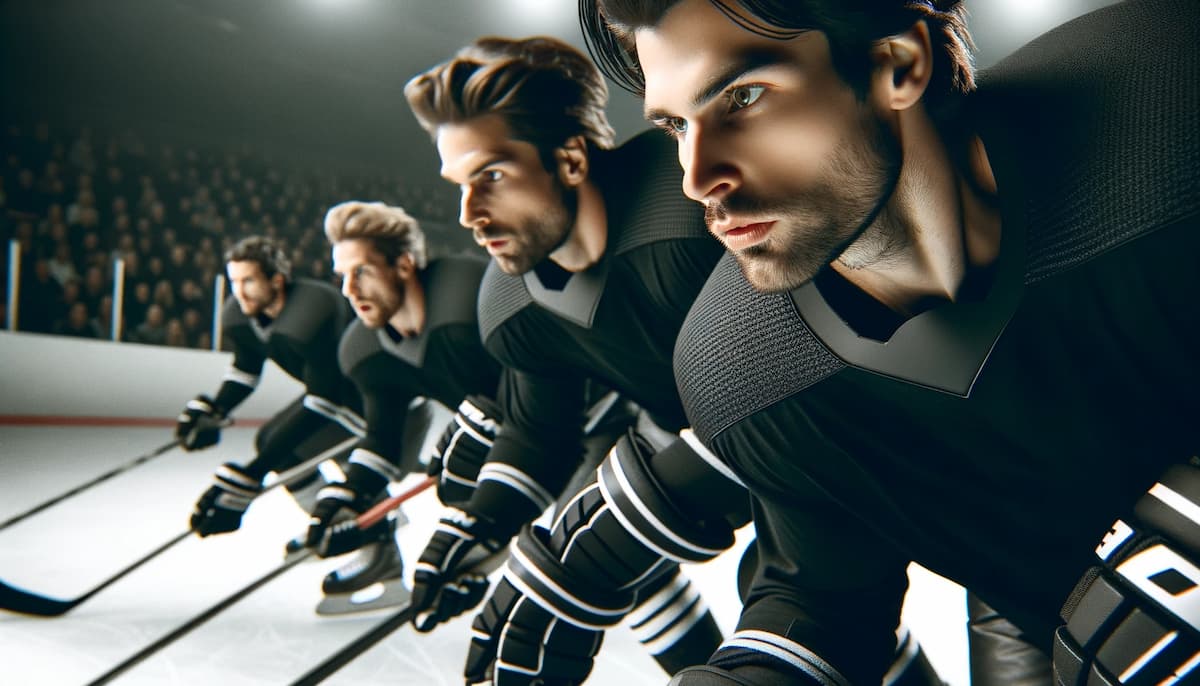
(0, 0, 1123, 686)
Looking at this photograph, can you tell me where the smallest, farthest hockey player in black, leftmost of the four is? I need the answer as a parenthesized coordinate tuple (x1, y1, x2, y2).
(175, 236, 362, 536)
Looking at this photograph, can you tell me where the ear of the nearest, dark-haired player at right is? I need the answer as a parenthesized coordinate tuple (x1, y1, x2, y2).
(871, 19, 934, 110)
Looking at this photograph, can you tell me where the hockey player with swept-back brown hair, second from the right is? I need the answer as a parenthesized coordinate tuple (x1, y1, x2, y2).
(404, 38, 945, 684)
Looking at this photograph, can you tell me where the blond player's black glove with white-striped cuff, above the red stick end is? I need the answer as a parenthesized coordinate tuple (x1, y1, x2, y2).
(426, 396, 500, 505)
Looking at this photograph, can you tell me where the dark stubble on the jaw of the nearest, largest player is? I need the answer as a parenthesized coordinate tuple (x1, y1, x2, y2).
(704, 110, 904, 293)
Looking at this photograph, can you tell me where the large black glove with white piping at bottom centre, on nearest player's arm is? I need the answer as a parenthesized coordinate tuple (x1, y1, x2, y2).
(463, 528, 634, 686)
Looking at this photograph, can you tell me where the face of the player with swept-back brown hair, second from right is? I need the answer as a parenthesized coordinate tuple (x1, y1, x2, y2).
(437, 114, 575, 275)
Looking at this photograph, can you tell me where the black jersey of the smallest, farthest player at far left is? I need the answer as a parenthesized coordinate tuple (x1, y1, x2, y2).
(216, 278, 359, 411)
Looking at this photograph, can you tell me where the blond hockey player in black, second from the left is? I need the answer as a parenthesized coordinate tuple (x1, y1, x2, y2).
(306, 201, 502, 614)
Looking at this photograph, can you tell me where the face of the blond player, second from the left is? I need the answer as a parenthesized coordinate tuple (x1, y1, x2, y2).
(334, 240, 404, 329)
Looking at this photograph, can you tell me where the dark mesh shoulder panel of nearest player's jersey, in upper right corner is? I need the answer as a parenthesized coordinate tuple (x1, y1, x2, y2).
(968, 0, 1200, 283)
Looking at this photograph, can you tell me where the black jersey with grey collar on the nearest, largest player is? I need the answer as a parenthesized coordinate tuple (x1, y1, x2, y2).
(676, 0, 1200, 684)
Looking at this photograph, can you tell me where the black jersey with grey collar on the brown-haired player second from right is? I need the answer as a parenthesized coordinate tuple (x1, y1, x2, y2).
(479, 132, 721, 525)
